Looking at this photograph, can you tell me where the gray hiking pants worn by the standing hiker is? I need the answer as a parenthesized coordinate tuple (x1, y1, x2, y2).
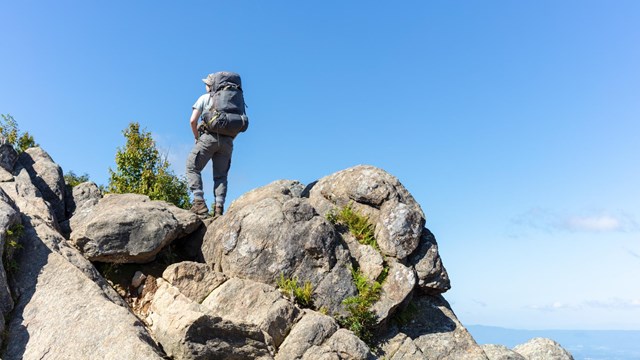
(187, 133, 233, 205)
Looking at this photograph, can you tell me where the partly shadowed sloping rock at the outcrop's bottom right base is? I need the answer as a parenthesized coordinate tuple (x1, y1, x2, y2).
(381, 295, 487, 360)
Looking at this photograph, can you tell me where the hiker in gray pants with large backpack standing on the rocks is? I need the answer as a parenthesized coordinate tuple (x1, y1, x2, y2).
(187, 71, 249, 217)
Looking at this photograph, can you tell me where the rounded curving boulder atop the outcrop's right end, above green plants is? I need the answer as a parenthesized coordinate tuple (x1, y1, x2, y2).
(305, 165, 425, 260)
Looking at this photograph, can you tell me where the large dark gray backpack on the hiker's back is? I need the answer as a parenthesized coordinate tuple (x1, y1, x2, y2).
(202, 71, 249, 138)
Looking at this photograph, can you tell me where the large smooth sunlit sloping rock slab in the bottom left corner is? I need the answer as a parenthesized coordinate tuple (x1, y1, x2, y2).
(0, 147, 162, 360)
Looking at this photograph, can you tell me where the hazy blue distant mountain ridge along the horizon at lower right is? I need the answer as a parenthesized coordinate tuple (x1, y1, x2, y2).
(467, 325, 640, 360)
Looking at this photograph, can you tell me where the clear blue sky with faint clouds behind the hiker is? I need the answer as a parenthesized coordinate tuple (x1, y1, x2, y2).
(0, 0, 640, 330)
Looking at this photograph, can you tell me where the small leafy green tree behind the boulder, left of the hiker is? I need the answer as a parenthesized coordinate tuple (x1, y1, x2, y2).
(107, 122, 191, 209)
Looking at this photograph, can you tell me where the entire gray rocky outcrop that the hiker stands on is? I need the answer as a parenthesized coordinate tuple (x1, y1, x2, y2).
(0, 146, 571, 360)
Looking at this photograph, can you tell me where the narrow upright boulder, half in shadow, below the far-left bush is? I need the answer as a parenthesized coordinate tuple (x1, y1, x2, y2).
(16, 147, 66, 221)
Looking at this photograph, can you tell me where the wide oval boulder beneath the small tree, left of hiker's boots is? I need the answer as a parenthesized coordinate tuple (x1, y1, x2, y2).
(69, 194, 201, 263)
